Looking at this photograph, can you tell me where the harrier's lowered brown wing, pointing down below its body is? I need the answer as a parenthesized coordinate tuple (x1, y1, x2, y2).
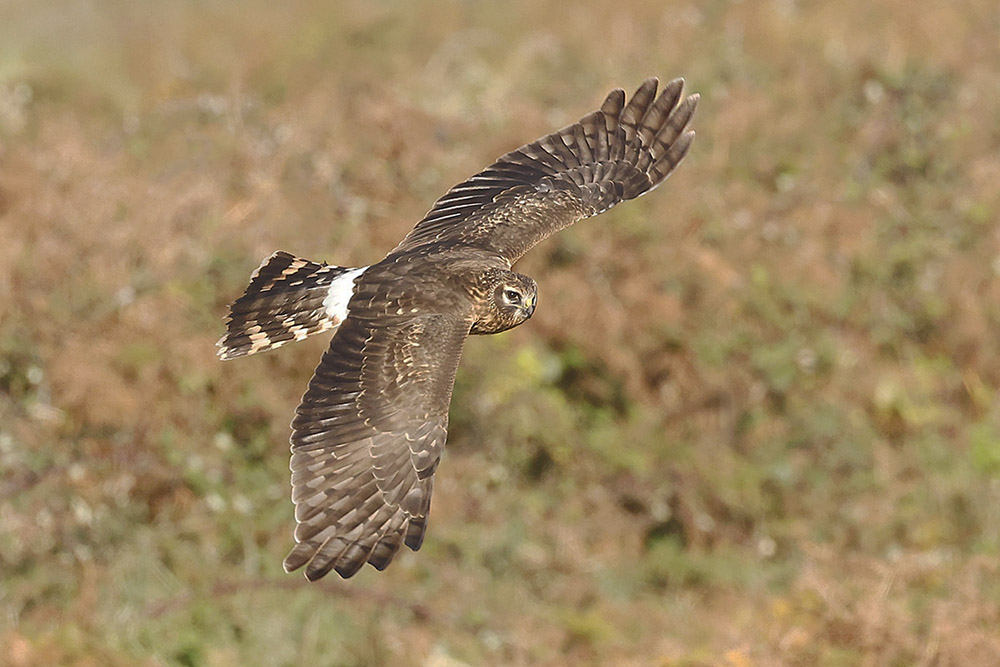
(284, 305, 470, 580)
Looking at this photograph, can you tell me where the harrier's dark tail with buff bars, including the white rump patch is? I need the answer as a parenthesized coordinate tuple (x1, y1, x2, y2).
(218, 251, 361, 360)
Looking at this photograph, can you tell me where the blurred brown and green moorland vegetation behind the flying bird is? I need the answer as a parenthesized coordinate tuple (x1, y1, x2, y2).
(0, 0, 1000, 666)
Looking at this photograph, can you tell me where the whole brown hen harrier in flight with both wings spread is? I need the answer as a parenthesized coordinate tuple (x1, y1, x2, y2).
(219, 78, 698, 581)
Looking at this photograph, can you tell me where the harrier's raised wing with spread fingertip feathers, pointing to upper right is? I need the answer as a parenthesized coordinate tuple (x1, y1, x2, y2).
(393, 78, 699, 264)
